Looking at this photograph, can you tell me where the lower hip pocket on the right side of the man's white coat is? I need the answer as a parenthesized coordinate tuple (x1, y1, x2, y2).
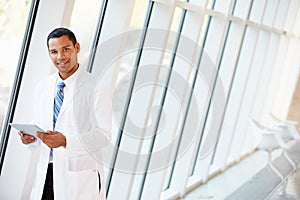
(67, 170, 100, 200)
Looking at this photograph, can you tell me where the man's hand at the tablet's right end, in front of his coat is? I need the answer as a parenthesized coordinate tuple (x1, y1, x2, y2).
(37, 131, 67, 148)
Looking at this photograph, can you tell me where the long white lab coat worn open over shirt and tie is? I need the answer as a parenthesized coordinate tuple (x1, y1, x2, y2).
(31, 68, 112, 200)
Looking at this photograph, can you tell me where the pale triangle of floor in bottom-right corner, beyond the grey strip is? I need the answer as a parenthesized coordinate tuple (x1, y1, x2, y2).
(270, 168, 300, 200)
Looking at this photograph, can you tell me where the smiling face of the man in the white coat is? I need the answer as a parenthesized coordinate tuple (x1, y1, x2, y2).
(48, 35, 80, 80)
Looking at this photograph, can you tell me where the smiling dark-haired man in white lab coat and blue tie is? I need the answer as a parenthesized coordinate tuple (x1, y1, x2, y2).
(19, 28, 112, 200)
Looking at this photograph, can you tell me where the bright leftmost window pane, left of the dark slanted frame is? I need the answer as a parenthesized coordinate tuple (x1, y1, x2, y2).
(0, 0, 31, 136)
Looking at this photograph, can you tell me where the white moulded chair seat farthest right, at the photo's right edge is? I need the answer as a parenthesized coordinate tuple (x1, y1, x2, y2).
(270, 113, 300, 141)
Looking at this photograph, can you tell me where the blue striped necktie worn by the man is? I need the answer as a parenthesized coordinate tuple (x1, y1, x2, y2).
(50, 82, 65, 162)
